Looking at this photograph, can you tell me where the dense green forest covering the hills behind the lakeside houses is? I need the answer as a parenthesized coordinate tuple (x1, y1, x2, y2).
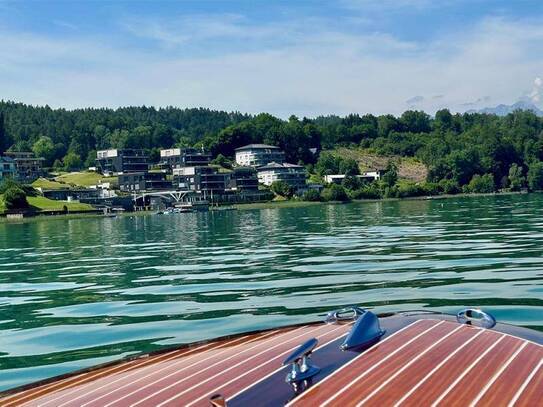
(0, 101, 543, 196)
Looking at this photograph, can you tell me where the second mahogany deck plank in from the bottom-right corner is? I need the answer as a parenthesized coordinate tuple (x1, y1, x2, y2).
(478, 343, 543, 406)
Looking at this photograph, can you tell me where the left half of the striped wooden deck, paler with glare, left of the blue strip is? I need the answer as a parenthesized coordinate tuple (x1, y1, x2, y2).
(0, 324, 350, 407)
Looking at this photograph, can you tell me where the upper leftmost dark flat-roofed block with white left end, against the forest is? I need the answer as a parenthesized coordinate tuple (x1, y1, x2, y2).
(96, 149, 149, 174)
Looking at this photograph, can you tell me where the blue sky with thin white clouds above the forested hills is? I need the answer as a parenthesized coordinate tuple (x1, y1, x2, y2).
(0, 0, 543, 118)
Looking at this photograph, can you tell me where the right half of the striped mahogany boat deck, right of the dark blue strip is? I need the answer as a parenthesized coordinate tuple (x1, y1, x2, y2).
(289, 319, 543, 407)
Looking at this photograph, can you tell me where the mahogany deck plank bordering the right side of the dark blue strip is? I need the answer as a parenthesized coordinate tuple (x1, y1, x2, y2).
(289, 319, 440, 406)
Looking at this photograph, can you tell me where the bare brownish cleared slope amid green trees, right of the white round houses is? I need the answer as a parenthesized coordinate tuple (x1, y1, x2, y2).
(330, 147, 428, 182)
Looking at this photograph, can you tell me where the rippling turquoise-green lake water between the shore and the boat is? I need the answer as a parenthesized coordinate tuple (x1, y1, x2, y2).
(0, 194, 543, 389)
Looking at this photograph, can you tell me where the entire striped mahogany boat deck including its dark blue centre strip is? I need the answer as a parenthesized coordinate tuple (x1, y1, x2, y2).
(0, 318, 543, 407)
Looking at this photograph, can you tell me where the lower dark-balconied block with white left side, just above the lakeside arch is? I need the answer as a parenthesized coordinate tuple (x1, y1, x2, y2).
(173, 166, 229, 195)
